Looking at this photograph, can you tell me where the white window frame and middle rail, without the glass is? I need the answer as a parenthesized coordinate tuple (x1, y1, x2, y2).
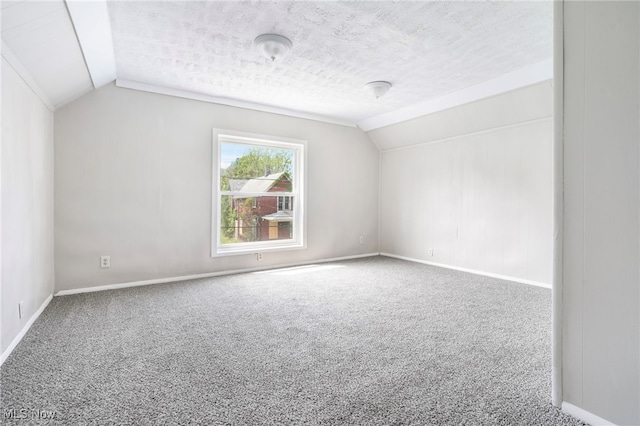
(211, 129, 307, 257)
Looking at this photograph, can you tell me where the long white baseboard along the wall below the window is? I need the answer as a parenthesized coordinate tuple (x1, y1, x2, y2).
(54, 252, 380, 297)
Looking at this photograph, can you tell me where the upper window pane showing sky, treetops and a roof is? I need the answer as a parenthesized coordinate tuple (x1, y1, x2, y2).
(220, 142, 294, 192)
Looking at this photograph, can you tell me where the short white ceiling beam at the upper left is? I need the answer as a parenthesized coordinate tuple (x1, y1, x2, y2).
(65, 0, 116, 89)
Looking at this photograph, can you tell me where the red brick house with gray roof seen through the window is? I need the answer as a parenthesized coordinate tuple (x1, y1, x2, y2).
(229, 172, 293, 241)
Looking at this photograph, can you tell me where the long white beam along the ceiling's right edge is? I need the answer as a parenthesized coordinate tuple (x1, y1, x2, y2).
(358, 58, 553, 132)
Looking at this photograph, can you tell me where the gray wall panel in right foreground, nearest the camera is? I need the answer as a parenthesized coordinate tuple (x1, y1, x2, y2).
(562, 2, 640, 425)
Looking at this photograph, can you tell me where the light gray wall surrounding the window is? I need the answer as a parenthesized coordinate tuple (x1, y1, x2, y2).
(55, 85, 379, 291)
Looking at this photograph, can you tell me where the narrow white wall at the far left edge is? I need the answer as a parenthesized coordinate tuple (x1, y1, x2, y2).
(0, 58, 54, 353)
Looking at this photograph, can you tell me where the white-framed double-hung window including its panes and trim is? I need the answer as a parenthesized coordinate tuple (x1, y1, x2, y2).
(211, 129, 306, 256)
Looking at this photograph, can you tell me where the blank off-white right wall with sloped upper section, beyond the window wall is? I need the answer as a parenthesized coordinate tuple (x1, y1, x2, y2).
(374, 82, 553, 285)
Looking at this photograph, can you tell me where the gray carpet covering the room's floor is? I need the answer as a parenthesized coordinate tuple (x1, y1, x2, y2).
(0, 257, 583, 425)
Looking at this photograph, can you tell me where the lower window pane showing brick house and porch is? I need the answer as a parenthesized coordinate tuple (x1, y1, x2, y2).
(220, 195, 294, 244)
